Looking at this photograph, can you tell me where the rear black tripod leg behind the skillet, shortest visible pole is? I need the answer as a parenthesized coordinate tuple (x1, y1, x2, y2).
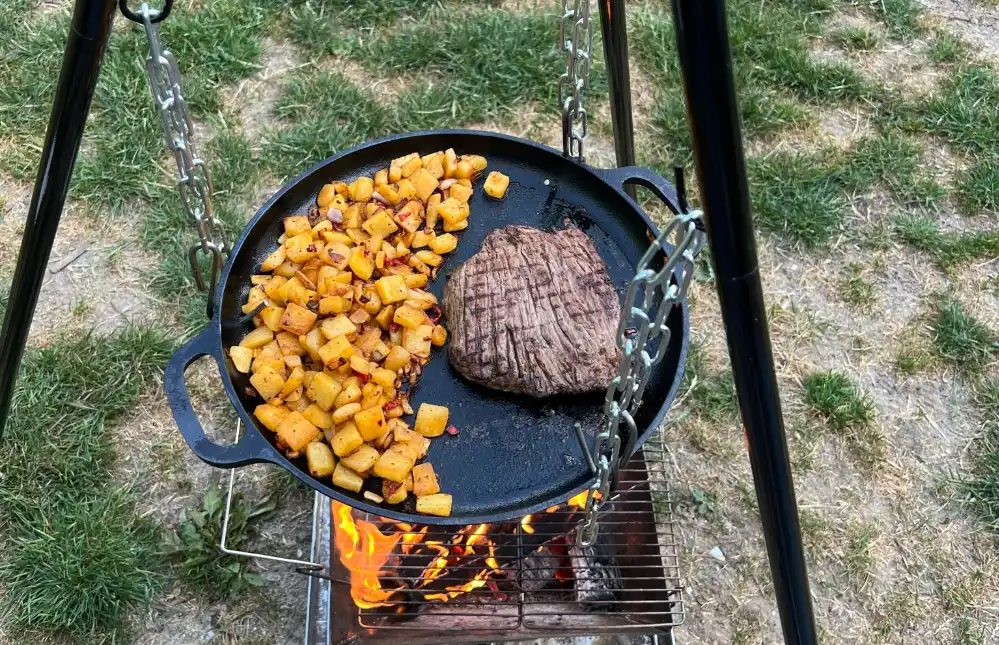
(597, 0, 635, 198)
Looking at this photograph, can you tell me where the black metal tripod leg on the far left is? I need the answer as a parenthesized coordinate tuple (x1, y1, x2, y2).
(0, 0, 115, 438)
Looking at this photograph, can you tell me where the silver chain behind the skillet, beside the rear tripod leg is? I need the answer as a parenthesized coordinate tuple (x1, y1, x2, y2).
(558, 0, 593, 162)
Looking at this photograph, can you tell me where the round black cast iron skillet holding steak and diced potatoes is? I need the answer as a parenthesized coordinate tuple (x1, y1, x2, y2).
(164, 130, 689, 525)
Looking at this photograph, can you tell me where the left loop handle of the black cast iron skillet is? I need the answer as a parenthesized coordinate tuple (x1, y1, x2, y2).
(163, 325, 270, 468)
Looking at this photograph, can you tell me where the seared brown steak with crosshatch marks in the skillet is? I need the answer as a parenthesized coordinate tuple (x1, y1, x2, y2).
(444, 226, 621, 397)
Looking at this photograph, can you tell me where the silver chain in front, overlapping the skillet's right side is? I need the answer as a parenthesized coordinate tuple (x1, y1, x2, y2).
(578, 211, 707, 546)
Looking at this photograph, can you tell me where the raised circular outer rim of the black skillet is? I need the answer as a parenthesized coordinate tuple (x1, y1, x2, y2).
(209, 129, 690, 526)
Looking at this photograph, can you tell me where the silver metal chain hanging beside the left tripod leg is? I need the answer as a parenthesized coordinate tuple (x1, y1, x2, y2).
(139, 2, 230, 317)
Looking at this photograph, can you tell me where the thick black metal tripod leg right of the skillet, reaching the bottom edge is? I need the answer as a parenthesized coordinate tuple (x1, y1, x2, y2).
(673, 0, 816, 645)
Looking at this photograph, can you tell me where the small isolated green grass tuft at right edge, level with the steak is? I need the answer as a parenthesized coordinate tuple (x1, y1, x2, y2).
(933, 297, 999, 374)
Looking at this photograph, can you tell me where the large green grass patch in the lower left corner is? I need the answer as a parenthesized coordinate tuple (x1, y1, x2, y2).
(0, 330, 172, 640)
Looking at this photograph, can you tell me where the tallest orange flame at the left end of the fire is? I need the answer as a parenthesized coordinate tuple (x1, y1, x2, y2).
(333, 502, 401, 609)
